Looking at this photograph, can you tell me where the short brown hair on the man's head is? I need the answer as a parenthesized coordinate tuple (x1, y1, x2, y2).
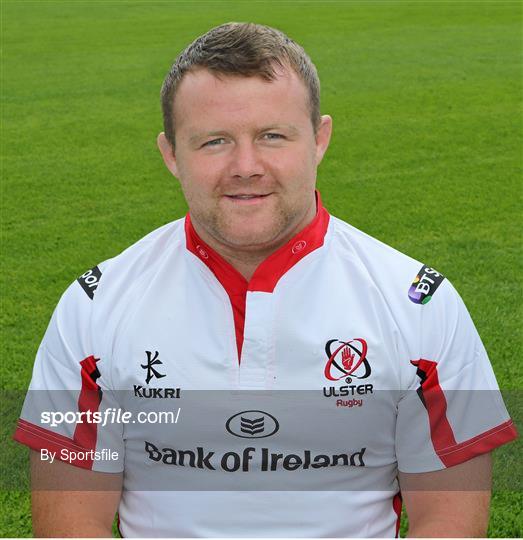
(161, 23, 320, 148)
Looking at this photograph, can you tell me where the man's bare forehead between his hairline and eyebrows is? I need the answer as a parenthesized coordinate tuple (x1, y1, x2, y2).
(174, 69, 310, 132)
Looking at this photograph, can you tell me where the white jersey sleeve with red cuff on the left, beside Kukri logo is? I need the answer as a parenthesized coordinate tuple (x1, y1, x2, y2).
(14, 267, 123, 472)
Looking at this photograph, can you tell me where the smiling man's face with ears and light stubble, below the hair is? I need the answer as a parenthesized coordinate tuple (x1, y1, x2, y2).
(159, 69, 331, 252)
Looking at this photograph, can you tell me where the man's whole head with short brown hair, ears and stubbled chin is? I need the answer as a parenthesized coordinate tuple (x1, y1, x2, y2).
(158, 23, 331, 259)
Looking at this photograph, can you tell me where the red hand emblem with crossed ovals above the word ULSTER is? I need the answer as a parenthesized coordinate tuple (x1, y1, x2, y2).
(324, 338, 371, 383)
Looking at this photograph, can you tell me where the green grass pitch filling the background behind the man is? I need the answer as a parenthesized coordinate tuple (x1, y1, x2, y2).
(0, 0, 523, 537)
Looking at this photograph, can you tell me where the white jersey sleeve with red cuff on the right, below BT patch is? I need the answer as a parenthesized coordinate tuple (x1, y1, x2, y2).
(396, 281, 517, 473)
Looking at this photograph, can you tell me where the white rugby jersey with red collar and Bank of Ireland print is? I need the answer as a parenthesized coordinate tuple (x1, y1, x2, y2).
(15, 193, 516, 537)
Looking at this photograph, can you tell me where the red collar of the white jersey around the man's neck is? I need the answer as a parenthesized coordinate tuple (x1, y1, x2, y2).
(185, 191, 330, 296)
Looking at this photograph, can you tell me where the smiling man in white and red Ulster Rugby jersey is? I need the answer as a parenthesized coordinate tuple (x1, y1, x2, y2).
(16, 23, 516, 537)
